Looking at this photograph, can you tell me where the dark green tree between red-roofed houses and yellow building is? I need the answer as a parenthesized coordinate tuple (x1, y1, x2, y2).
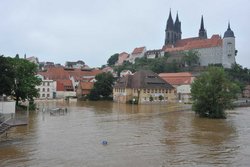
(89, 72, 115, 100)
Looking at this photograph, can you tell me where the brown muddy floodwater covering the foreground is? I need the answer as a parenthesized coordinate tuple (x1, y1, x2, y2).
(0, 102, 250, 167)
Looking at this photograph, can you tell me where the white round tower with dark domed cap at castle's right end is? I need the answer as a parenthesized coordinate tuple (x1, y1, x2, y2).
(222, 23, 235, 68)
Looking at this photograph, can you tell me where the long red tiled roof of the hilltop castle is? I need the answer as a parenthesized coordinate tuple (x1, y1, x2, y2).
(162, 35, 222, 52)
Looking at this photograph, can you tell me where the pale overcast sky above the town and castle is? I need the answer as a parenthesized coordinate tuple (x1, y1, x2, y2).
(0, 0, 250, 68)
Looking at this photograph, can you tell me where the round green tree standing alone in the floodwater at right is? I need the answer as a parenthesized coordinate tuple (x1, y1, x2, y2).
(191, 67, 239, 118)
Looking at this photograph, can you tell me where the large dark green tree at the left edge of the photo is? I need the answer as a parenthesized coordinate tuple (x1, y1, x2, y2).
(0, 56, 41, 105)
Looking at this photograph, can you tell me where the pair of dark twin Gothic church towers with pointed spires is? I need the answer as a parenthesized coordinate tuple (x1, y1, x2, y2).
(164, 10, 181, 45)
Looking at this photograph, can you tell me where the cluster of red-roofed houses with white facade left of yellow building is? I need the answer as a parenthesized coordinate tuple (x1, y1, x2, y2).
(37, 67, 102, 99)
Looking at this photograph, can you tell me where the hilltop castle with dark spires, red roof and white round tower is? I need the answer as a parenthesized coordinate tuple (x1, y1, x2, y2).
(162, 11, 236, 68)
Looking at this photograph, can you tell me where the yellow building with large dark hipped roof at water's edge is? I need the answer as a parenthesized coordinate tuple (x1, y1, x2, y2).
(113, 70, 176, 104)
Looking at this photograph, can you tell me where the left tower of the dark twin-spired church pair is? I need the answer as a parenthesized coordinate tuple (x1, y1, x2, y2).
(165, 10, 175, 45)
